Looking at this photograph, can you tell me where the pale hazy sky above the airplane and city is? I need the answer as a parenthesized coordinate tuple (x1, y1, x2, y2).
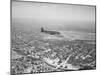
(12, 1, 95, 32)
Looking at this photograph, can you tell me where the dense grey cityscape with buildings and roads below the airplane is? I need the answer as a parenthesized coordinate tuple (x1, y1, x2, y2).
(11, 32, 96, 75)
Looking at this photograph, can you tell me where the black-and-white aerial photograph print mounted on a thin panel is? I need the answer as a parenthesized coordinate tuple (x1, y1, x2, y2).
(10, 0, 96, 75)
